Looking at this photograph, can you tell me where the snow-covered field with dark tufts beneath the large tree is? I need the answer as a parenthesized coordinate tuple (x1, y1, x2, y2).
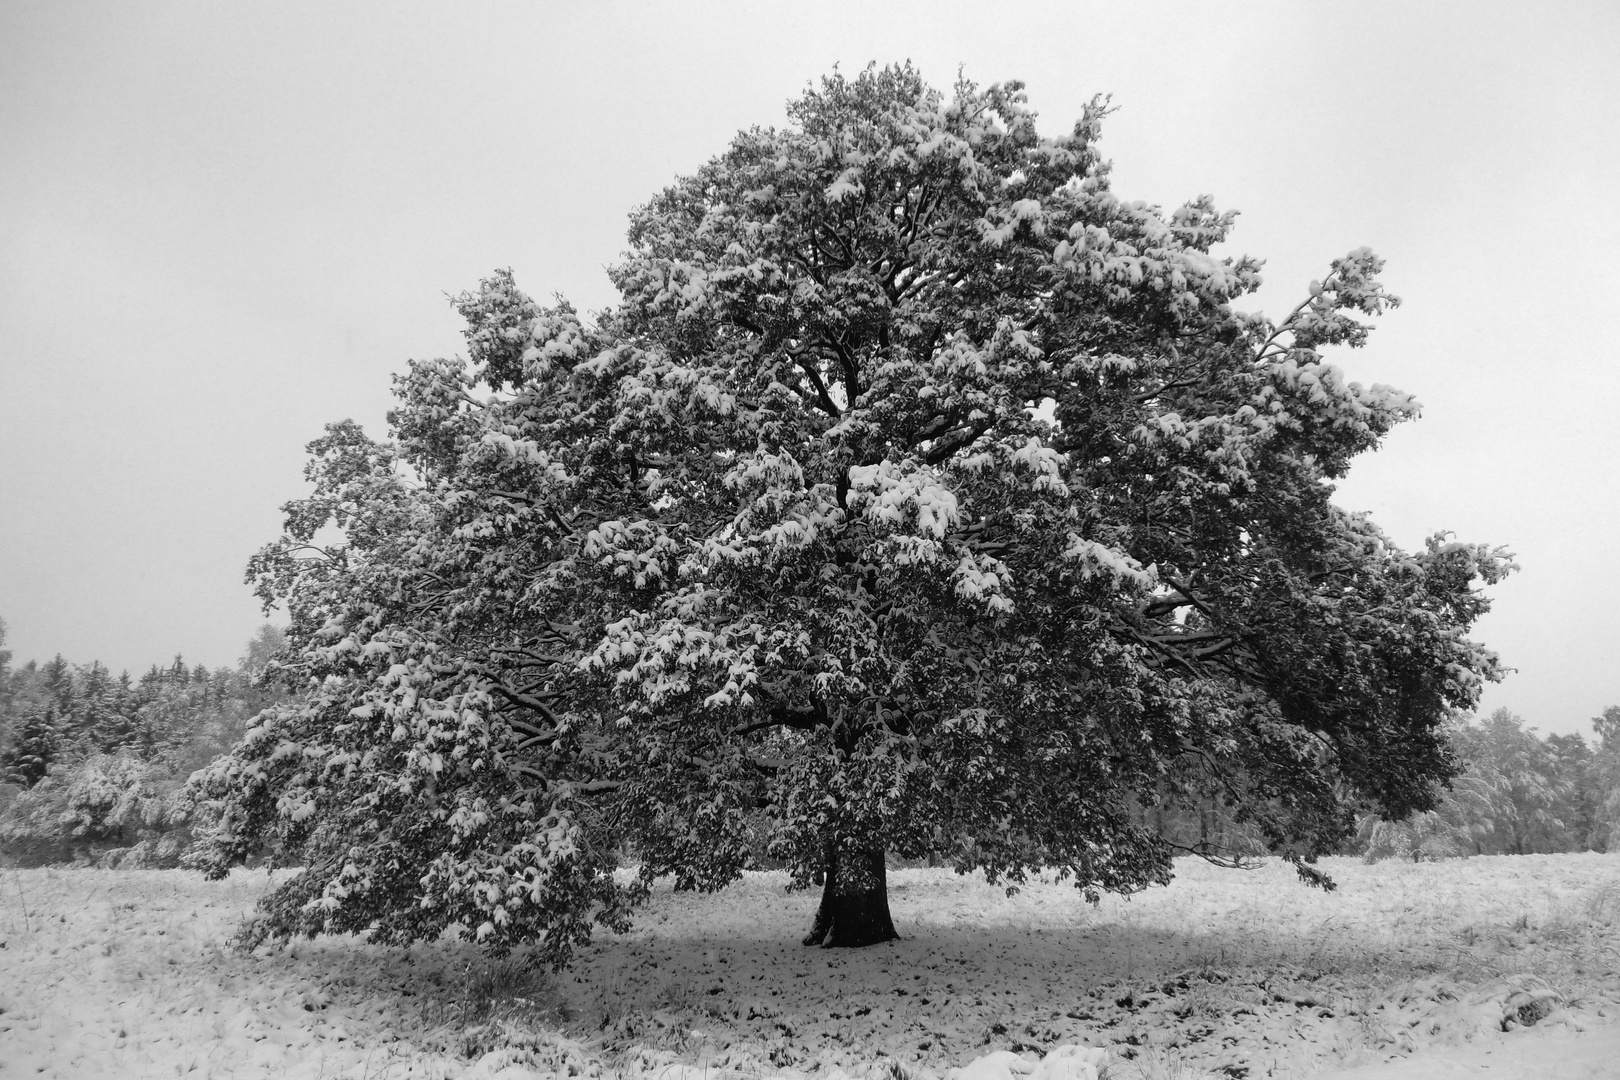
(0, 855, 1620, 1080)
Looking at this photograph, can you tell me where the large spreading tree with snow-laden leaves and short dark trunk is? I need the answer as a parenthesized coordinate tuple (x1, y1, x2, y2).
(199, 68, 1510, 962)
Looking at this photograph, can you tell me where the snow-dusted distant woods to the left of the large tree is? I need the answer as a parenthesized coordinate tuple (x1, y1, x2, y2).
(0, 620, 285, 866)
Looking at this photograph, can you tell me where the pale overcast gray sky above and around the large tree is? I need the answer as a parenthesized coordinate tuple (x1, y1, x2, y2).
(0, 0, 1620, 732)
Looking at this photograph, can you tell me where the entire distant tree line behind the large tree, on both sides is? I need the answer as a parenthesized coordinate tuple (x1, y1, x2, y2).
(0, 608, 1620, 866)
